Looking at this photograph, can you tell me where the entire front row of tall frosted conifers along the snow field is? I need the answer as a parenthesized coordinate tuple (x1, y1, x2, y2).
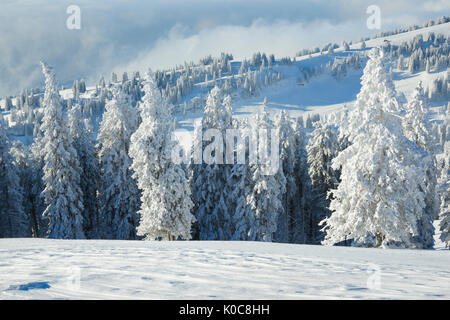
(0, 49, 450, 249)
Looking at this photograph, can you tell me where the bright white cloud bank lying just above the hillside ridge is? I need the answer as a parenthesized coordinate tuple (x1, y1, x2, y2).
(116, 19, 361, 72)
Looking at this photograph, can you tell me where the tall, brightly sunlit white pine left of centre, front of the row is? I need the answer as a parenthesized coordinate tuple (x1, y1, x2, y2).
(129, 72, 195, 240)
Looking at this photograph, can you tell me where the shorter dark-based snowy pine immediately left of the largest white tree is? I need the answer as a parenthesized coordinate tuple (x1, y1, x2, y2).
(307, 121, 339, 242)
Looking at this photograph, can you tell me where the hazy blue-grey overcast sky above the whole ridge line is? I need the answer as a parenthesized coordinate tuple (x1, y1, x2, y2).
(0, 0, 450, 96)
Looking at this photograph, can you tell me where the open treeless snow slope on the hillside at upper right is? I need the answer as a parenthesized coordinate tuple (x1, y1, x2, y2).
(177, 23, 450, 130)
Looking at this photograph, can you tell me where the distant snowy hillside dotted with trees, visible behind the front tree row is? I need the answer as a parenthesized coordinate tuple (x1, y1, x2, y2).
(0, 22, 450, 139)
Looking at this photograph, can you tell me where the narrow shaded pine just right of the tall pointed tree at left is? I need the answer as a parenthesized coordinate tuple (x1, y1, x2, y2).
(68, 104, 99, 239)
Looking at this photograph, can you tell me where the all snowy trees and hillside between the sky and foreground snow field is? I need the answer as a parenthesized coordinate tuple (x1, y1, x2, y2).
(0, 17, 450, 249)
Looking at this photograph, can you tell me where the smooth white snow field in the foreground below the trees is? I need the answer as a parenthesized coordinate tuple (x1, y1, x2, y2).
(0, 239, 450, 299)
